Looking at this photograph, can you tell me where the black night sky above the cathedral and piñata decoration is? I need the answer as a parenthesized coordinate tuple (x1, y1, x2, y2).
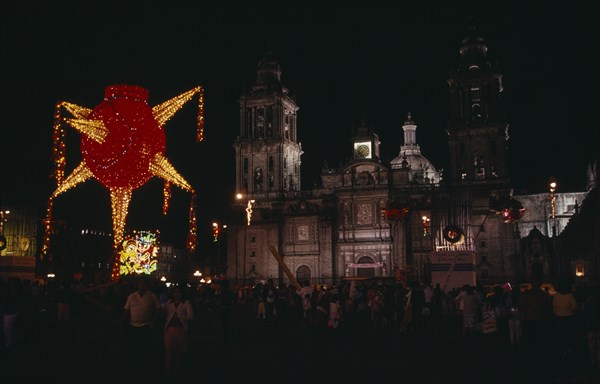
(0, 0, 600, 250)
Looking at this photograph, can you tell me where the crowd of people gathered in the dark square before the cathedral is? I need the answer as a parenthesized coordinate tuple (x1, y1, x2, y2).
(0, 277, 600, 376)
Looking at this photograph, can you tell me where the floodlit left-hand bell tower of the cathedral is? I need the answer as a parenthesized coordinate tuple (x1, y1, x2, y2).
(233, 52, 303, 199)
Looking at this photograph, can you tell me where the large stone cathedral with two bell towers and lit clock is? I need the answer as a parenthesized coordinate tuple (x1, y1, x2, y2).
(226, 24, 596, 289)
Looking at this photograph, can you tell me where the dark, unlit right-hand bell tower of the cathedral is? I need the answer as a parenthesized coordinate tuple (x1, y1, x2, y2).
(447, 22, 508, 182)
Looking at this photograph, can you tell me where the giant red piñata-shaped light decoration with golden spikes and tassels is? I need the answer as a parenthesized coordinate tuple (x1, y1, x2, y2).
(40, 85, 204, 280)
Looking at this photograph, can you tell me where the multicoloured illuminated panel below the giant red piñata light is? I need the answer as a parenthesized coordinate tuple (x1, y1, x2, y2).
(119, 231, 158, 275)
